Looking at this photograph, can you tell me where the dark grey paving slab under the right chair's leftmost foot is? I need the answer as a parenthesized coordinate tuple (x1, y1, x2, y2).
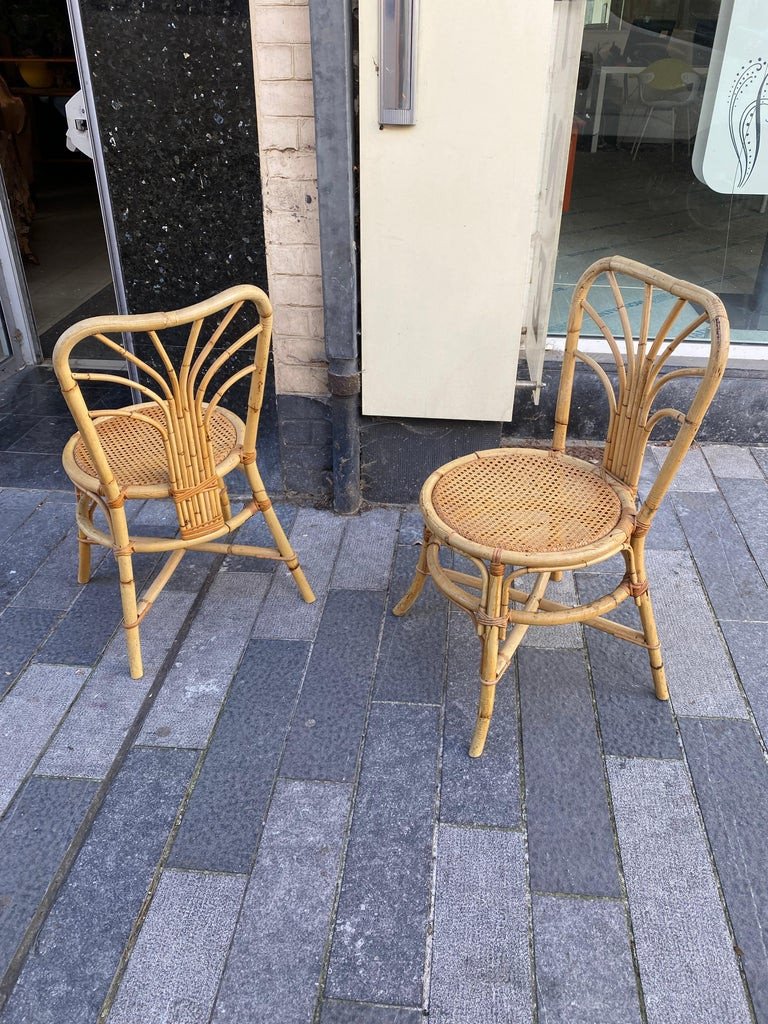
(374, 544, 449, 703)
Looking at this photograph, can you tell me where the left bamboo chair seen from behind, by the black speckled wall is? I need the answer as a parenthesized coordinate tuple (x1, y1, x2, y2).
(53, 285, 314, 679)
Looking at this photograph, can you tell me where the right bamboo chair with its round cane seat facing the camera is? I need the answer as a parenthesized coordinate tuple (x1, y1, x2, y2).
(393, 256, 729, 757)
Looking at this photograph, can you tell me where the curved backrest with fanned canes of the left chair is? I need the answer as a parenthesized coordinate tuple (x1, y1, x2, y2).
(53, 285, 272, 538)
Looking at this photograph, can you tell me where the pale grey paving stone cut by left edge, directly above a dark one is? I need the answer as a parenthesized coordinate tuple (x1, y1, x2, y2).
(0, 665, 88, 814)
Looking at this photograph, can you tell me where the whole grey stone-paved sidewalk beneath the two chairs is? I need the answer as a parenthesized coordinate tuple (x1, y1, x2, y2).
(0, 368, 768, 1024)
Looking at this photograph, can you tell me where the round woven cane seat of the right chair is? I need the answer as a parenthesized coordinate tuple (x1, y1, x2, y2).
(422, 449, 630, 554)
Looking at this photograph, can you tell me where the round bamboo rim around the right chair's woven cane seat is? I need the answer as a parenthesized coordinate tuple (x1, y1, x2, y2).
(419, 447, 637, 569)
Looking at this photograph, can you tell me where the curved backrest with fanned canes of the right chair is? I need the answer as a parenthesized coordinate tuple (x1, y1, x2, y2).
(552, 256, 730, 527)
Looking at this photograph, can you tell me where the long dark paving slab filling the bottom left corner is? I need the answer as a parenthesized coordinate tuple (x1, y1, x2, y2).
(0, 749, 197, 1024)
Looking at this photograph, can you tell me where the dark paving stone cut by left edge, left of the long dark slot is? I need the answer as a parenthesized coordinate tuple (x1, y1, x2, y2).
(0, 777, 96, 978)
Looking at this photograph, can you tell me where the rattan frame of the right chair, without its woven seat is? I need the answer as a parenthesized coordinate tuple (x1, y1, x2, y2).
(393, 256, 729, 757)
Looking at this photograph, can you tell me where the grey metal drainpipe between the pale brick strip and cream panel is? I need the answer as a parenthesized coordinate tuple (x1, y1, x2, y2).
(309, 0, 360, 514)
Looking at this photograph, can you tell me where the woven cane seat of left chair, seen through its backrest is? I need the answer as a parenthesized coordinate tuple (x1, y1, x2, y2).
(68, 402, 245, 489)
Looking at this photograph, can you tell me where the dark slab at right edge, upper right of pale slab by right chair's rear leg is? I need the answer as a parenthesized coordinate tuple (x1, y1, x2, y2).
(674, 494, 768, 622)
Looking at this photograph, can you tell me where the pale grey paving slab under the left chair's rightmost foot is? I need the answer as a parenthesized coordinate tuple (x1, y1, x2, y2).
(253, 509, 345, 640)
